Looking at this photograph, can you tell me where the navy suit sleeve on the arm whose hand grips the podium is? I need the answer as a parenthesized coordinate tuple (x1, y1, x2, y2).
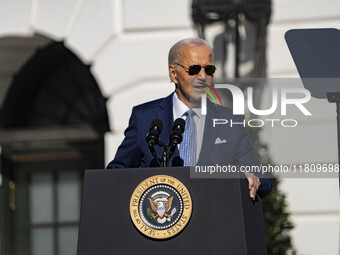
(235, 114, 272, 197)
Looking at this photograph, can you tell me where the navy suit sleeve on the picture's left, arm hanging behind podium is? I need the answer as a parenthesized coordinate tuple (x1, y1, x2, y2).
(107, 107, 141, 168)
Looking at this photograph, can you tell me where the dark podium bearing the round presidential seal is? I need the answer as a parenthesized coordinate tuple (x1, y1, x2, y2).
(77, 167, 267, 255)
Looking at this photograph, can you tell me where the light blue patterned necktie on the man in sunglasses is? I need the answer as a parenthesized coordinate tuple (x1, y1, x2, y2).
(179, 110, 197, 166)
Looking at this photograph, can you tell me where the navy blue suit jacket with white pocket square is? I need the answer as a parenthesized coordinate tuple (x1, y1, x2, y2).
(107, 94, 271, 197)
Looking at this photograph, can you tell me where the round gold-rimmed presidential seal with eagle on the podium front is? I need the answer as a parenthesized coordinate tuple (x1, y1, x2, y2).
(130, 175, 192, 239)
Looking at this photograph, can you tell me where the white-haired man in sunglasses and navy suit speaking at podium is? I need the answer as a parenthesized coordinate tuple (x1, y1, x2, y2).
(107, 38, 271, 199)
